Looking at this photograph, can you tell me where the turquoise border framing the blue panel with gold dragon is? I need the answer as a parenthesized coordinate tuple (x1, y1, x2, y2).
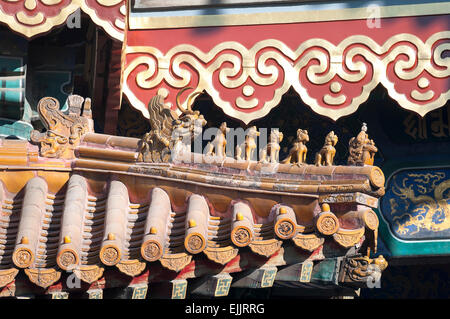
(375, 159, 450, 257)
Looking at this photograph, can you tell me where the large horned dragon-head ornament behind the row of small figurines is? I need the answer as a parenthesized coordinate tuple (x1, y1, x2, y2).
(138, 87, 206, 162)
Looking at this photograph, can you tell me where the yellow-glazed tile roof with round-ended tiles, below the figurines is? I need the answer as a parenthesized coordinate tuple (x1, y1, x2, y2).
(0, 133, 384, 296)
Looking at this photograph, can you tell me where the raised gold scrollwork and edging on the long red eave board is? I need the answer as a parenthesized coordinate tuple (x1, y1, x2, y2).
(123, 31, 450, 123)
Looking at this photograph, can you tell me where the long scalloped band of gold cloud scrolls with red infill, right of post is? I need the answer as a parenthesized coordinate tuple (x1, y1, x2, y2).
(123, 31, 450, 123)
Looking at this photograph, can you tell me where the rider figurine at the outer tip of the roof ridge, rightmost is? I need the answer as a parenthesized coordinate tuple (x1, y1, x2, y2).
(347, 123, 378, 166)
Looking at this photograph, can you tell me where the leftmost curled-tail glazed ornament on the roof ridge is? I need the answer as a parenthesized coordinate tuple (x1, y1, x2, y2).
(30, 97, 92, 159)
